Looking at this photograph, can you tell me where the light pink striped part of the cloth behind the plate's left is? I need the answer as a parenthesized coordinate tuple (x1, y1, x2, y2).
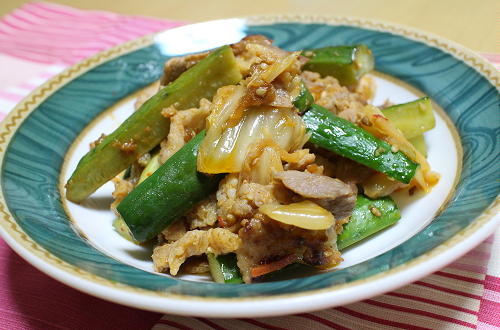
(0, 2, 180, 65)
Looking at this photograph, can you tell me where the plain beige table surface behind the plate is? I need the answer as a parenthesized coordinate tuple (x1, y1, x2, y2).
(0, 0, 500, 53)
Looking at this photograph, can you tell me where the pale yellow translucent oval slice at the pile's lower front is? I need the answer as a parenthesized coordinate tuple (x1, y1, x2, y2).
(259, 201, 335, 230)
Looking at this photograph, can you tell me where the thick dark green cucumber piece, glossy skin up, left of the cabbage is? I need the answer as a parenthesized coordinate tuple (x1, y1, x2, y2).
(117, 131, 222, 242)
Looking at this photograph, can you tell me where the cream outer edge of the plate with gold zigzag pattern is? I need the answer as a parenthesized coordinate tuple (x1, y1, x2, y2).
(0, 14, 500, 317)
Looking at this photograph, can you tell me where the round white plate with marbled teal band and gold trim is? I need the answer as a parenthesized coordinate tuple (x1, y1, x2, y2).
(0, 16, 500, 317)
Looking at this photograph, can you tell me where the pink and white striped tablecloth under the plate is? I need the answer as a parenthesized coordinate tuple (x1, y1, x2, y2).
(0, 2, 500, 329)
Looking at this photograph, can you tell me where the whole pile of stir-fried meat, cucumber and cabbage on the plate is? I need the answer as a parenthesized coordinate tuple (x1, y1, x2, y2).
(66, 35, 439, 283)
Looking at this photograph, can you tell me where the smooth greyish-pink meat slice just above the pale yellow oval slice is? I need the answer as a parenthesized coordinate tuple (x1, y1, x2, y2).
(275, 171, 357, 221)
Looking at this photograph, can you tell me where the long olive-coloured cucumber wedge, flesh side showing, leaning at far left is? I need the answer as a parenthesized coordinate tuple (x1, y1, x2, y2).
(66, 46, 241, 203)
